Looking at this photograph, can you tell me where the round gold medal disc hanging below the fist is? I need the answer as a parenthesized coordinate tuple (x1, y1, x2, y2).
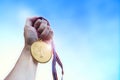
(31, 41, 52, 63)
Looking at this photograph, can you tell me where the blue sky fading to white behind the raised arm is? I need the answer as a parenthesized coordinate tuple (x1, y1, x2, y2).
(0, 0, 120, 80)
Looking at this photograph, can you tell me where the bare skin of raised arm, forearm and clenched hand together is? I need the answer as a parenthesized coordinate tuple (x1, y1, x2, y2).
(5, 17, 53, 80)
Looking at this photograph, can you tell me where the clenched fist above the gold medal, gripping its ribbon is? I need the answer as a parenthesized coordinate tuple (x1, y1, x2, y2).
(24, 17, 53, 45)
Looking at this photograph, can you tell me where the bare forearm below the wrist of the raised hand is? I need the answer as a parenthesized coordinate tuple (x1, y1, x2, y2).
(5, 46, 37, 80)
